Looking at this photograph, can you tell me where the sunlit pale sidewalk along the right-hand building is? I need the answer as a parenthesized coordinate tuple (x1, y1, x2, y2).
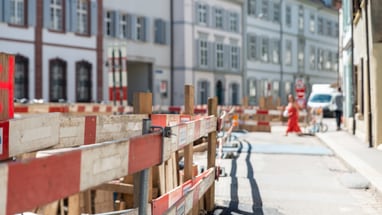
(316, 121, 382, 195)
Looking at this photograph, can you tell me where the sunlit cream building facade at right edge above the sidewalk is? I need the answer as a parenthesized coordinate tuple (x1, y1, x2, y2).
(350, 0, 382, 147)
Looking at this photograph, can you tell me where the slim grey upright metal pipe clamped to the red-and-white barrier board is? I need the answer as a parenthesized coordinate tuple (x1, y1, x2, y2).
(138, 119, 151, 215)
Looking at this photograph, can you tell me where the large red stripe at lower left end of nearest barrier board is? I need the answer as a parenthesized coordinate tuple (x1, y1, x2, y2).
(7, 151, 81, 214)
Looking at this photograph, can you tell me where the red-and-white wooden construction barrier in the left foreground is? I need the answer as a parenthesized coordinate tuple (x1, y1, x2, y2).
(0, 86, 218, 215)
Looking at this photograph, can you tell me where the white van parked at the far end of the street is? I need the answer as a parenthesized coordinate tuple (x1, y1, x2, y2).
(307, 84, 336, 117)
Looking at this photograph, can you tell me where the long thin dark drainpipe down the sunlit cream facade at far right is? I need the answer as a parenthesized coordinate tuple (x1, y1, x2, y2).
(365, 0, 373, 148)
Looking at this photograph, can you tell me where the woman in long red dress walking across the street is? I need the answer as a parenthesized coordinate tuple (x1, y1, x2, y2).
(285, 94, 302, 136)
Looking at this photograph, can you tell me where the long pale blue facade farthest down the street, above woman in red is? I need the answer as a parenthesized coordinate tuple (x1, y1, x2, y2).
(245, 0, 338, 104)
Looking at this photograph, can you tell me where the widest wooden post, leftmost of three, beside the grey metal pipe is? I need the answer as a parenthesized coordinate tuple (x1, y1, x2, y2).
(133, 92, 153, 207)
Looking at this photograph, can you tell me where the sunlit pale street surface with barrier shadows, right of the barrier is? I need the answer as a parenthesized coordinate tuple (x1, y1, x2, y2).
(194, 119, 382, 215)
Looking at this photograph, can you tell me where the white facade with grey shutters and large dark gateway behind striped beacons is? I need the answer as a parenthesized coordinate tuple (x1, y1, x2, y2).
(103, 0, 171, 105)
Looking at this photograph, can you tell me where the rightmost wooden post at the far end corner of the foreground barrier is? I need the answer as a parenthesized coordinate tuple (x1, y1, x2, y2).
(206, 97, 218, 212)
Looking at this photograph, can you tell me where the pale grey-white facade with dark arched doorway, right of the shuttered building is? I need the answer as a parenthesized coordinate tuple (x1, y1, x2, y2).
(173, 0, 244, 105)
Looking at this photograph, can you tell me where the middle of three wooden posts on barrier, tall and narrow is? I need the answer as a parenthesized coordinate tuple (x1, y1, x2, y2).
(183, 85, 194, 181)
